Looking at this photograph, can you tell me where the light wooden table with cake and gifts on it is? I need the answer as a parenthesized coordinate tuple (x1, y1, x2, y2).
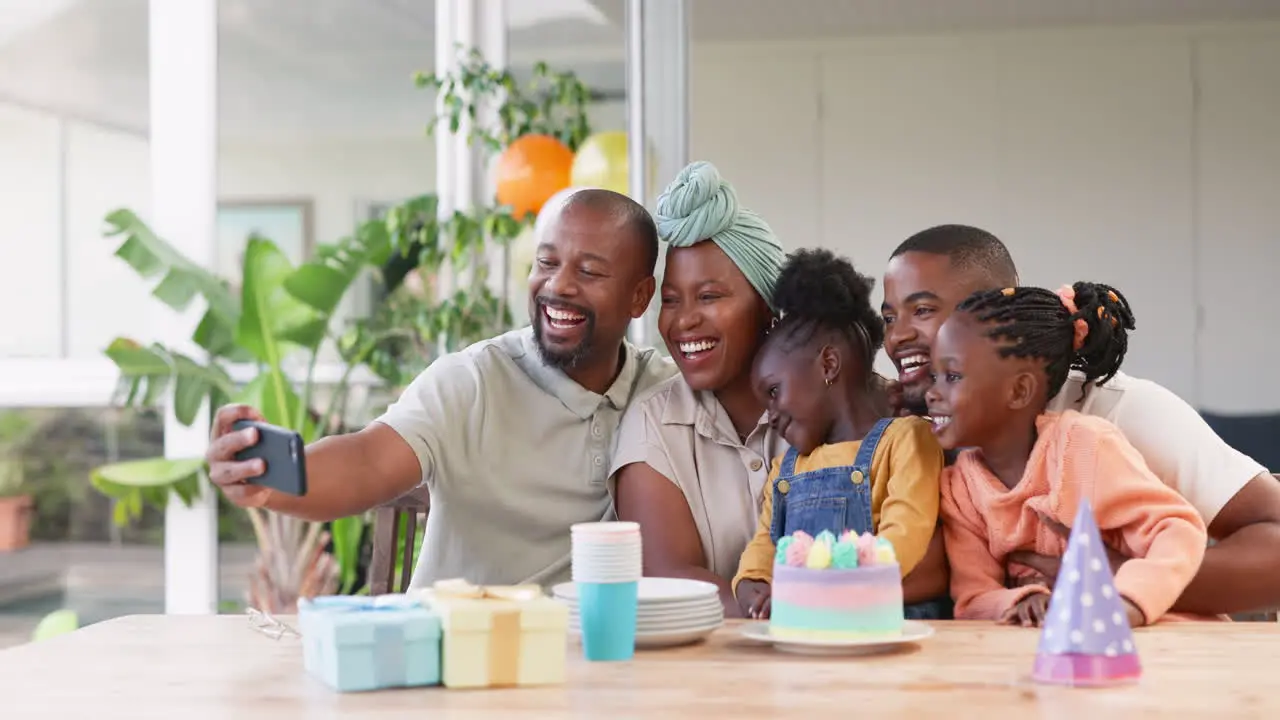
(0, 615, 1280, 720)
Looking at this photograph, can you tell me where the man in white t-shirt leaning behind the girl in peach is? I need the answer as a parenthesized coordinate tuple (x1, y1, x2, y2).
(881, 225, 1280, 615)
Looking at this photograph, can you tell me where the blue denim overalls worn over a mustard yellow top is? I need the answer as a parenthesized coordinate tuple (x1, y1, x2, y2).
(769, 418, 952, 620)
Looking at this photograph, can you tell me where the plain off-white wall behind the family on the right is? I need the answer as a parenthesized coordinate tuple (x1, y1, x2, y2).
(692, 26, 1280, 413)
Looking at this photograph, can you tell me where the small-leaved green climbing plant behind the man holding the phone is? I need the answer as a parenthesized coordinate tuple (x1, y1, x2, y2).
(339, 51, 591, 387)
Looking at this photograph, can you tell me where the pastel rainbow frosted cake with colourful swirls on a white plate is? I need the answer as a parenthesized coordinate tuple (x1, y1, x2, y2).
(769, 530, 904, 641)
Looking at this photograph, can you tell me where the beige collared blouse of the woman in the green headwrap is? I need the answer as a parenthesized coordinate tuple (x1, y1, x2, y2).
(608, 375, 787, 580)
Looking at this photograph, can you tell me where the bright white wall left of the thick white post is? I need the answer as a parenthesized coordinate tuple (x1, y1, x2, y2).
(0, 105, 150, 357)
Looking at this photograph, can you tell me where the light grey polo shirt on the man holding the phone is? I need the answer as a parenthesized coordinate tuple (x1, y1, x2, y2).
(373, 327, 676, 587)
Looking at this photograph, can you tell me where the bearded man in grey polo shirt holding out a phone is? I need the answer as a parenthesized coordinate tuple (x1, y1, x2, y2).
(207, 190, 675, 587)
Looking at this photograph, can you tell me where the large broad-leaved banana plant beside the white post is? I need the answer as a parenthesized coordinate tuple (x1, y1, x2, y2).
(91, 210, 392, 604)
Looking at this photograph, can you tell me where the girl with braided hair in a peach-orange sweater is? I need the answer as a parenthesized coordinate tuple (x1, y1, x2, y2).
(925, 282, 1207, 625)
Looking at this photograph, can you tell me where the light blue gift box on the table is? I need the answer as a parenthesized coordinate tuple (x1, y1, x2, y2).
(298, 594, 440, 692)
